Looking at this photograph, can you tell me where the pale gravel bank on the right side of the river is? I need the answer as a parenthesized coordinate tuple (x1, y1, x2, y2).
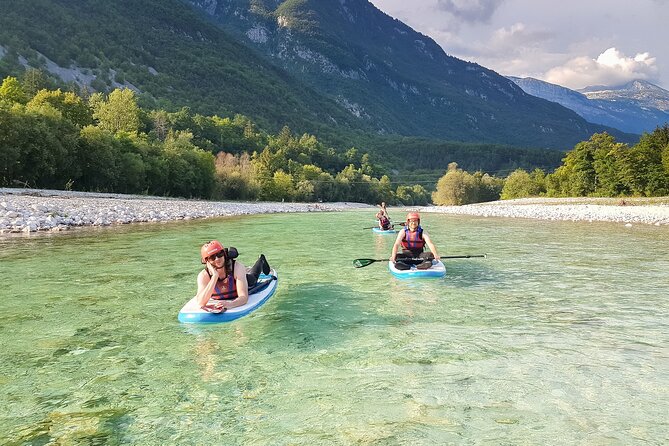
(421, 197, 669, 226)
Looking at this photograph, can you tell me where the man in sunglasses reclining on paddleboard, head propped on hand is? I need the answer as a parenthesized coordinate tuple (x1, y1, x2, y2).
(196, 240, 270, 312)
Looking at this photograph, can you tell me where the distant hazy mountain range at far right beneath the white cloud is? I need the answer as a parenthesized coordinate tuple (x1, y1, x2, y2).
(508, 76, 669, 134)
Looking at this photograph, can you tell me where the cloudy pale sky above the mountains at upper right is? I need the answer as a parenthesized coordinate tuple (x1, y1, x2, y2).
(370, 0, 669, 90)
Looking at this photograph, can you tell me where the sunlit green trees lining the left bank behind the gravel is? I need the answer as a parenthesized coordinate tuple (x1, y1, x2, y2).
(0, 76, 429, 204)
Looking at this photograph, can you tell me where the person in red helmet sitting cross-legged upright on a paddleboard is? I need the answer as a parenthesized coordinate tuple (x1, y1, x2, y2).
(390, 212, 439, 270)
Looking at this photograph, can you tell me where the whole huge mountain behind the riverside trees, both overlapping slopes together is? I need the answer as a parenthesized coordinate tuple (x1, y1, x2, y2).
(0, 0, 634, 153)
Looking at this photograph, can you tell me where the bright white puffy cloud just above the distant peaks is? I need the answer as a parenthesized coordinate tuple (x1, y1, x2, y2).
(543, 48, 658, 88)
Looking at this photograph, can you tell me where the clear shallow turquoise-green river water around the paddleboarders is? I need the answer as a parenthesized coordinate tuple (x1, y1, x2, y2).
(0, 210, 669, 445)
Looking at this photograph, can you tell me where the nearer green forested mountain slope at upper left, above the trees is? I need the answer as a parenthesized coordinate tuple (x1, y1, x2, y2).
(0, 0, 370, 141)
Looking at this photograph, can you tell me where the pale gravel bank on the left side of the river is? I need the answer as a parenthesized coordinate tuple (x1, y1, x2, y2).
(0, 188, 371, 234)
